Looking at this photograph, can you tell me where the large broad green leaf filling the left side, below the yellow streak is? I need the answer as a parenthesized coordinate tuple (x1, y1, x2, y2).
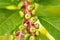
(0, 9, 22, 35)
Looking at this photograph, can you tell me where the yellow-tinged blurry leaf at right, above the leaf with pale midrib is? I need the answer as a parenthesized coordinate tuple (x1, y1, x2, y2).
(36, 5, 60, 17)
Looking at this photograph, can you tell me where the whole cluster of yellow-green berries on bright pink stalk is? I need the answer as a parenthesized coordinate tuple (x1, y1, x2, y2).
(10, 0, 40, 40)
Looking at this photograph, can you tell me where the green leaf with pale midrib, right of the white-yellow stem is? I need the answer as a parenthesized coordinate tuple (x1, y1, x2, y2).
(39, 17, 60, 40)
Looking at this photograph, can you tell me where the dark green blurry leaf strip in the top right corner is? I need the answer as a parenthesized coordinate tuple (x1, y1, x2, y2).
(35, 0, 60, 5)
